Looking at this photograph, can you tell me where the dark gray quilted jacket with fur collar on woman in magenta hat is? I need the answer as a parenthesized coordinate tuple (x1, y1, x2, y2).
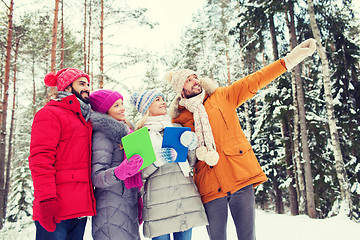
(91, 112, 140, 240)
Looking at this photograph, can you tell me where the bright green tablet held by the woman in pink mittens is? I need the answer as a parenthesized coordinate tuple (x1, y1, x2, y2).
(121, 127, 156, 171)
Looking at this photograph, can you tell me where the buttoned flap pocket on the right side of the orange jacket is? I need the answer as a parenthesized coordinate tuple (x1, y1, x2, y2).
(223, 140, 262, 181)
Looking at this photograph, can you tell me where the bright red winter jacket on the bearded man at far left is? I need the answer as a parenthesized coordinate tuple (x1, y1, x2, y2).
(29, 95, 96, 220)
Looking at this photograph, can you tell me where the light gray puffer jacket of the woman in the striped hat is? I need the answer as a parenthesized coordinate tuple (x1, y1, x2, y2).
(141, 125, 208, 238)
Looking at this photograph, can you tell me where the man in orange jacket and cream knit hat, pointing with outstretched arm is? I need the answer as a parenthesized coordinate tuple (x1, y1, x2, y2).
(165, 39, 316, 240)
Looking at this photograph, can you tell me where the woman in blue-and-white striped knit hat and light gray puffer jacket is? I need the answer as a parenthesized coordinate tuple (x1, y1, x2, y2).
(131, 90, 208, 240)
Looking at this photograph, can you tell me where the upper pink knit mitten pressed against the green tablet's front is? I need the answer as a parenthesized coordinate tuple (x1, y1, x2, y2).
(114, 154, 143, 180)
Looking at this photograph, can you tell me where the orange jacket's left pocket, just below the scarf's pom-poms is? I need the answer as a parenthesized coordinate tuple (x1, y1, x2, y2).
(194, 161, 217, 197)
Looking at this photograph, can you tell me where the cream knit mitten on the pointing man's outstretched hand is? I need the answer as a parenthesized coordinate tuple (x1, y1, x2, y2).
(283, 38, 316, 70)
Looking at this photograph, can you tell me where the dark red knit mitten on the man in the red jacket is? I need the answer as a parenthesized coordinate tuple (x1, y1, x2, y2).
(39, 198, 61, 232)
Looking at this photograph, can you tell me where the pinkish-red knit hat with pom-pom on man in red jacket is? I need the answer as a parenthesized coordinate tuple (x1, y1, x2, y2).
(44, 68, 90, 91)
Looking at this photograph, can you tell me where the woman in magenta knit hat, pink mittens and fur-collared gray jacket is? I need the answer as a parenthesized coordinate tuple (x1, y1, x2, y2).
(90, 90, 143, 240)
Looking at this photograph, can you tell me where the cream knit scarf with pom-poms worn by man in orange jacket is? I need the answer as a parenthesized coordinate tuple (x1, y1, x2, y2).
(179, 90, 219, 166)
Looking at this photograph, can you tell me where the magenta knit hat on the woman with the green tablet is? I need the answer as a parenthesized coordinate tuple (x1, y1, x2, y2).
(89, 90, 124, 113)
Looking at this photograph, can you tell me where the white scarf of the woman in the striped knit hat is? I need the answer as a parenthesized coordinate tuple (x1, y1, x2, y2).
(144, 115, 190, 177)
